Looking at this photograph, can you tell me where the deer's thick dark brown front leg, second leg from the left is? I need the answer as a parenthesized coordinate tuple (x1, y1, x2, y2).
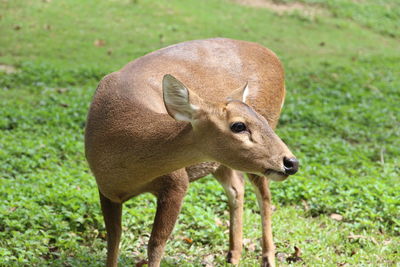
(147, 169, 189, 267)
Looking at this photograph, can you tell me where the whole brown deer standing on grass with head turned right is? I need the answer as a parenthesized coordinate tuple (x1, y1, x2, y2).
(85, 38, 298, 267)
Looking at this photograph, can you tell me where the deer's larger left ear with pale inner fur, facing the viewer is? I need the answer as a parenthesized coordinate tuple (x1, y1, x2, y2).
(162, 74, 199, 122)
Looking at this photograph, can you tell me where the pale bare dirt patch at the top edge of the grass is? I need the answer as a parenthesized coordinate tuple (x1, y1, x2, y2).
(231, 0, 324, 17)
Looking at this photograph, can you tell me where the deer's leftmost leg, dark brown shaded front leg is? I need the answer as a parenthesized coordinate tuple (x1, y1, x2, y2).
(99, 191, 122, 267)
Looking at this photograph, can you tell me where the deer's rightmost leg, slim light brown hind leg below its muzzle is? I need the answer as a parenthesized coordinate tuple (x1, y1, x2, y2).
(249, 174, 275, 267)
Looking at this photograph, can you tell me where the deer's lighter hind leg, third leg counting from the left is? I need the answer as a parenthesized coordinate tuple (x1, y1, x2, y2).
(214, 165, 244, 264)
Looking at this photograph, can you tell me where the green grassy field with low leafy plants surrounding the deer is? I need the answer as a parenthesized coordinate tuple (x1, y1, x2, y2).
(0, 0, 400, 266)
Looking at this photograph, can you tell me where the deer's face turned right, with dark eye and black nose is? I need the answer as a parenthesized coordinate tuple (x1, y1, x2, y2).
(164, 74, 298, 181)
